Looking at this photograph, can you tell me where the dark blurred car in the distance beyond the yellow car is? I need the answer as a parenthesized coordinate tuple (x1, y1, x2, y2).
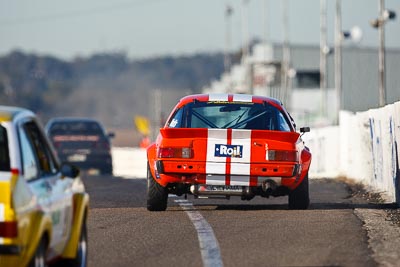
(46, 117, 114, 175)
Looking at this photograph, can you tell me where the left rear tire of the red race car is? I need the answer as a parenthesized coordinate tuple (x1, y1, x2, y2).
(147, 164, 168, 211)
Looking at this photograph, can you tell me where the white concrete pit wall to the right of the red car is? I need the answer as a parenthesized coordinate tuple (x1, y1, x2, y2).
(303, 102, 400, 204)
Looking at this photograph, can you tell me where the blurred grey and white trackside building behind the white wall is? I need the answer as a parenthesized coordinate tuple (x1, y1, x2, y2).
(203, 44, 400, 126)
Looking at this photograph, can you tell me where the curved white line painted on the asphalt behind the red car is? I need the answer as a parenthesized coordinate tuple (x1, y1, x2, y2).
(174, 199, 224, 267)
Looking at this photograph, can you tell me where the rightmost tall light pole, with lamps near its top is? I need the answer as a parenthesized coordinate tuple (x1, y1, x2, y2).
(370, 0, 396, 107)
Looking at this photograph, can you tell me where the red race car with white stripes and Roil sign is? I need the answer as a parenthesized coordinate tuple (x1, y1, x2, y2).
(147, 94, 311, 211)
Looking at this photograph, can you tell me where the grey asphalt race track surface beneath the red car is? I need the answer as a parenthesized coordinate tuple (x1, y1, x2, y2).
(83, 176, 400, 267)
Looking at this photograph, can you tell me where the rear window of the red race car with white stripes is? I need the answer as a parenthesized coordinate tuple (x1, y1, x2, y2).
(167, 102, 291, 132)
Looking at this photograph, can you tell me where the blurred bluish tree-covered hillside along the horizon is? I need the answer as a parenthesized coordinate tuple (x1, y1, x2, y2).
(0, 51, 231, 127)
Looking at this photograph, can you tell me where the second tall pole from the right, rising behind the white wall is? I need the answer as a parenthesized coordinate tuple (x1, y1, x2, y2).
(335, 0, 342, 124)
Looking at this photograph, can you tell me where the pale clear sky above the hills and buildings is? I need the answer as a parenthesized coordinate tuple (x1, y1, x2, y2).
(0, 0, 400, 59)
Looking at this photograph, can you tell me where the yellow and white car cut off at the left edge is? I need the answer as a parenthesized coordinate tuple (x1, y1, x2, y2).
(0, 106, 89, 267)
